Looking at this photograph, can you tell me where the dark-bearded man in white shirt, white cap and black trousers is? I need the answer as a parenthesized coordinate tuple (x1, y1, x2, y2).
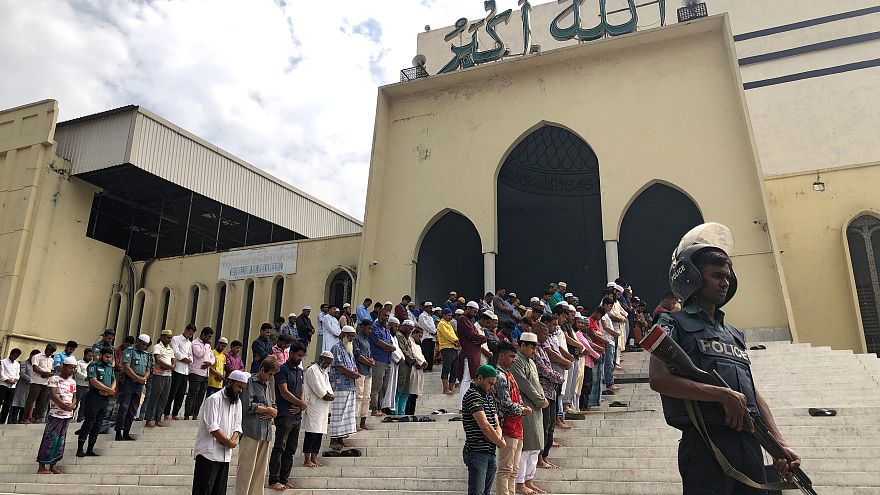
(192, 371, 250, 495)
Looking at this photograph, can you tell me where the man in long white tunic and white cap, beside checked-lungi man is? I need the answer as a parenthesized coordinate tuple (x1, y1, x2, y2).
(302, 351, 334, 467)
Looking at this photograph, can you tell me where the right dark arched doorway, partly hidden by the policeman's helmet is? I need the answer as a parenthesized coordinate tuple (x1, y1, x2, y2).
(617, 183, 703, 309)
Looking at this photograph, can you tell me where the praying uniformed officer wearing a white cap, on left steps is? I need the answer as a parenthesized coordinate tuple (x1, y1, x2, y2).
(116, 333, 152, 440)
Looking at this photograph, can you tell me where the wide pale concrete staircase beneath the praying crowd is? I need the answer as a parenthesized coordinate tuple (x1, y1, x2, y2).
(0, 343, 880, 495)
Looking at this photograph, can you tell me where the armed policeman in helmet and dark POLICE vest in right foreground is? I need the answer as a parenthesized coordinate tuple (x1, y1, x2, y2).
(650, 224, 800, 495)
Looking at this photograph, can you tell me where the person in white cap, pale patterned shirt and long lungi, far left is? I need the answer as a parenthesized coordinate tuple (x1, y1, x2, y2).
(37, 356, 76, 474)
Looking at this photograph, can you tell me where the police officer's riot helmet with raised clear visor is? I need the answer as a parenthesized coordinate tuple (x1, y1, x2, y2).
(669, 222, 737, 307)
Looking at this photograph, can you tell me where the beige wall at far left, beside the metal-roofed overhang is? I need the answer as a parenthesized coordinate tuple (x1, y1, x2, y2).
(0, 100, 123, 353)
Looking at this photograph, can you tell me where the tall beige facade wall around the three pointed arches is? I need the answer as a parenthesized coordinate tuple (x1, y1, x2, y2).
(358, 17, 787, 334)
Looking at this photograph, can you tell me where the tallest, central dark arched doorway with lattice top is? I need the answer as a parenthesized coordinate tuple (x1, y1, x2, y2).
(495, 125, 605, 301)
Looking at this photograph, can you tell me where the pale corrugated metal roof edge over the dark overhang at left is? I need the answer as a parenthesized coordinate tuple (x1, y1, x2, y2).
(55, 106, 363, 237)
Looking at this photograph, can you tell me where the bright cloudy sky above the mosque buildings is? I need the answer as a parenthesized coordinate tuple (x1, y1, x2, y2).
(0, 0, 496, 218)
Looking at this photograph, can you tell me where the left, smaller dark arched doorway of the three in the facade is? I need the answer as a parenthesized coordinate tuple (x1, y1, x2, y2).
(415, 211, 483, 301)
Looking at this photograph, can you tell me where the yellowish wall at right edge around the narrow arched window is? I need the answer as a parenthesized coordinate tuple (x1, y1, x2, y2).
(766, 163, 880, 352)
